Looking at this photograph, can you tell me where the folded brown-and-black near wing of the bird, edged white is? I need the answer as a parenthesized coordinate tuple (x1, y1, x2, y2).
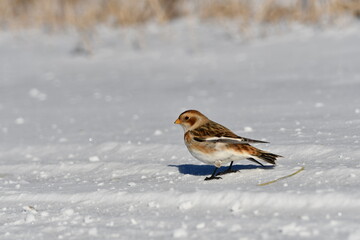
(191, 121, 268, 144)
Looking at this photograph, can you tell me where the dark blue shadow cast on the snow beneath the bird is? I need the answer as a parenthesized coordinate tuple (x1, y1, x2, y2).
(168, 164, 274, 176)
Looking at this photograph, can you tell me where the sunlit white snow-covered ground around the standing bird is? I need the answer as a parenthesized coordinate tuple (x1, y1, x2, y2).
(0, 21, 360, 240)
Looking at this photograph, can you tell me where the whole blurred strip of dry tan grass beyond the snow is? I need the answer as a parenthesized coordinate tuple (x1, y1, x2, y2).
(0, 0, 360, 29)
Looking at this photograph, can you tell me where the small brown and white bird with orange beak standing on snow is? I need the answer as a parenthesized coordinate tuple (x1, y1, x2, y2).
(174, 110, 282, 181)
